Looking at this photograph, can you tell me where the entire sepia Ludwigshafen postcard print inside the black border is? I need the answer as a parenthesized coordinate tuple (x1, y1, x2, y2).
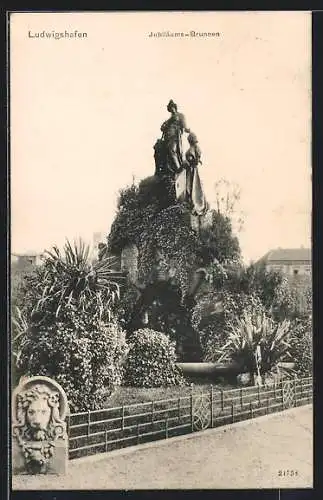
(8, 11, 313, 491)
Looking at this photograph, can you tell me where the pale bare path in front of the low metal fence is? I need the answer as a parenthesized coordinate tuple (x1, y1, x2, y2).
(13, 405, 313, 490)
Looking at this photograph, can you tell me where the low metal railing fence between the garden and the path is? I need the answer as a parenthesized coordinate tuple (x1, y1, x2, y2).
(68, 377, 313, 459)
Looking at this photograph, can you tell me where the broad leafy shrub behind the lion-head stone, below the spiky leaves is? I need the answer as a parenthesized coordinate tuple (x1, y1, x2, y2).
(16, 305, 127, 411)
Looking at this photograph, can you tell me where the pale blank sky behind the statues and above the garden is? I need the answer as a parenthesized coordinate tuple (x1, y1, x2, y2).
(10, 12, 311, 261)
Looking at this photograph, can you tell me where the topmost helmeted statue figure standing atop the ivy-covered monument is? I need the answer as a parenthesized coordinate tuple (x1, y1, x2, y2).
(161, 100, 190, 174)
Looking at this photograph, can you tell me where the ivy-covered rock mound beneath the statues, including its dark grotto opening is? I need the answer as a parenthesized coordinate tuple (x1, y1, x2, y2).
(108, 176, 240, 361)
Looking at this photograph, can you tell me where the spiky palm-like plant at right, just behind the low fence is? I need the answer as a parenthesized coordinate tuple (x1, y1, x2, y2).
(218, 312, 291, 375)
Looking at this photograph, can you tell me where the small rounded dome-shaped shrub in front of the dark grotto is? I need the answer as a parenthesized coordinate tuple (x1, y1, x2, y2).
(124, 328, 184, 387)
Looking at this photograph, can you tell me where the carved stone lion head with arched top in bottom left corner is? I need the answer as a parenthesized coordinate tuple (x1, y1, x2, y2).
(12, 377, 68, 474)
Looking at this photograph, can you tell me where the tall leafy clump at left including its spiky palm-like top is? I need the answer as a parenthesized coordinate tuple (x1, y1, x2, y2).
(12, 242, 126, 411)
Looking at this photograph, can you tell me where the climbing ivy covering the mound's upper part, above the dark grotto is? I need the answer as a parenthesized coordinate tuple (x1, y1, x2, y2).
(108, 176, 240, 297)
